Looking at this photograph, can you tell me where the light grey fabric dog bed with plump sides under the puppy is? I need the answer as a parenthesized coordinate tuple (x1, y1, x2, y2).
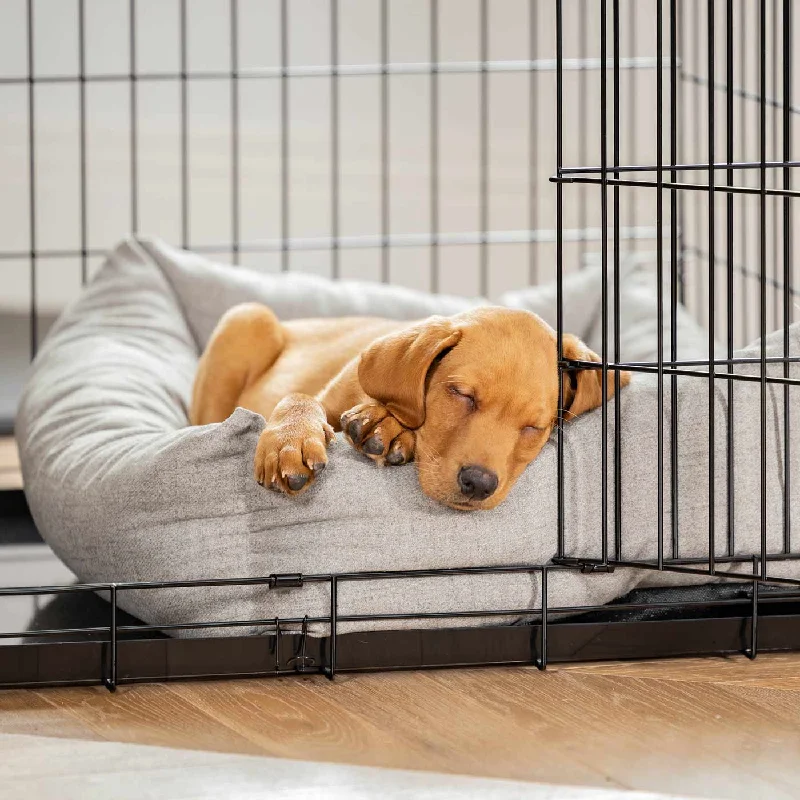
(17, 234, 800, 635)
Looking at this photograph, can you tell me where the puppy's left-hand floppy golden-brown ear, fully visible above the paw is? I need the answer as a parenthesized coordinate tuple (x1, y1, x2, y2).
(358, 317, 461, 429)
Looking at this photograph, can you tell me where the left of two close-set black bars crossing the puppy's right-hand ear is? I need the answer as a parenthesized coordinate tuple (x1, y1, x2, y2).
(600, 0, 608, 564)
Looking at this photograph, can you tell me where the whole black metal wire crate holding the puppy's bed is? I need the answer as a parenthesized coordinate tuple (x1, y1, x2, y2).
(0, 0, 800, 689)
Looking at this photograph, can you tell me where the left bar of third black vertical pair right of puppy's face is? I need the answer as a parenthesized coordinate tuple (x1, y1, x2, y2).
(707, 0, 717, 575)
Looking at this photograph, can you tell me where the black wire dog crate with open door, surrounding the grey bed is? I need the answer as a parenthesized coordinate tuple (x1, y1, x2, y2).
(0, 0, 800, 689)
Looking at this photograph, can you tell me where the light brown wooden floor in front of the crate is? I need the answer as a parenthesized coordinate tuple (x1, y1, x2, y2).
(0, 655, 800, 800)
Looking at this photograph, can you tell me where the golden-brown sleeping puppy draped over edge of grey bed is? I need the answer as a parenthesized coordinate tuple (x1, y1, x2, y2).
(190, 303, 630, 510)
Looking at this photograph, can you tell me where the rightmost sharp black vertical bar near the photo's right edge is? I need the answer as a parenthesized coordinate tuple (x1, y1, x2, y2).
(783, 0, 794, 553)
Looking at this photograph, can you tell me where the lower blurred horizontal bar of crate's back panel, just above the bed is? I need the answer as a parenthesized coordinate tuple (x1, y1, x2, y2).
(0, 226, 669, 261)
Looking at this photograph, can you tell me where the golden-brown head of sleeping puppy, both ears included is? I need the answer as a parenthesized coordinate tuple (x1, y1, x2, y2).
(359, 307, 630, 510)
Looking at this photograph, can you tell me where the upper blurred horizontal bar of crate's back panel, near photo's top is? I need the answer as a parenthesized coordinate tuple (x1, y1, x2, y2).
(0, 58, 669, 86)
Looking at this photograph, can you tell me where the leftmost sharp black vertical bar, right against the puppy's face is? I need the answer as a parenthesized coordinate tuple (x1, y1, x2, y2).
(556, 0, 564, 558)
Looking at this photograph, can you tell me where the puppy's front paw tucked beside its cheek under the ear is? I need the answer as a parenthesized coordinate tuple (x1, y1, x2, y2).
(340, 403, 416, 467)
